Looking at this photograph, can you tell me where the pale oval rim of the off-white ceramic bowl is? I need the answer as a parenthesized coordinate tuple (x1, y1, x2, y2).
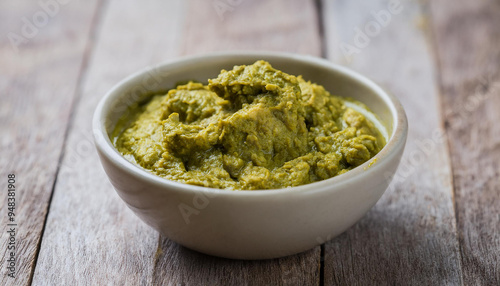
(92, 51, 408, 196)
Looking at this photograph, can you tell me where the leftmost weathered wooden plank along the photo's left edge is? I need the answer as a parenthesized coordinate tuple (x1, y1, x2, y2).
(0, 1, 98, 285)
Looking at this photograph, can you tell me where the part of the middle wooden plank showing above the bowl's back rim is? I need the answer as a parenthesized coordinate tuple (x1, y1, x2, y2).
(182, 0, 321, 55)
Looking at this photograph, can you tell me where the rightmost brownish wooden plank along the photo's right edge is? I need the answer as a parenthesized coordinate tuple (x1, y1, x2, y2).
(431, 0, 500, 285)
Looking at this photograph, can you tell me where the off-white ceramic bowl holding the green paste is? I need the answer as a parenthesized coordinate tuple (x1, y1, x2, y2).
(93, 52, 408, 259)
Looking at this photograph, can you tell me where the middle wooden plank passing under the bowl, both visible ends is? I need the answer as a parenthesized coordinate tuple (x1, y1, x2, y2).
(153, 0, 321, 285)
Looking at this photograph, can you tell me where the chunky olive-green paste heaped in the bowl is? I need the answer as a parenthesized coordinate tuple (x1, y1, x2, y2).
(112, 61, 385, 190)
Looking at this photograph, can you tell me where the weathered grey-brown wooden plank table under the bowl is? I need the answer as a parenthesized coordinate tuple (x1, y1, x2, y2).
(0, 0, 500, 285)
